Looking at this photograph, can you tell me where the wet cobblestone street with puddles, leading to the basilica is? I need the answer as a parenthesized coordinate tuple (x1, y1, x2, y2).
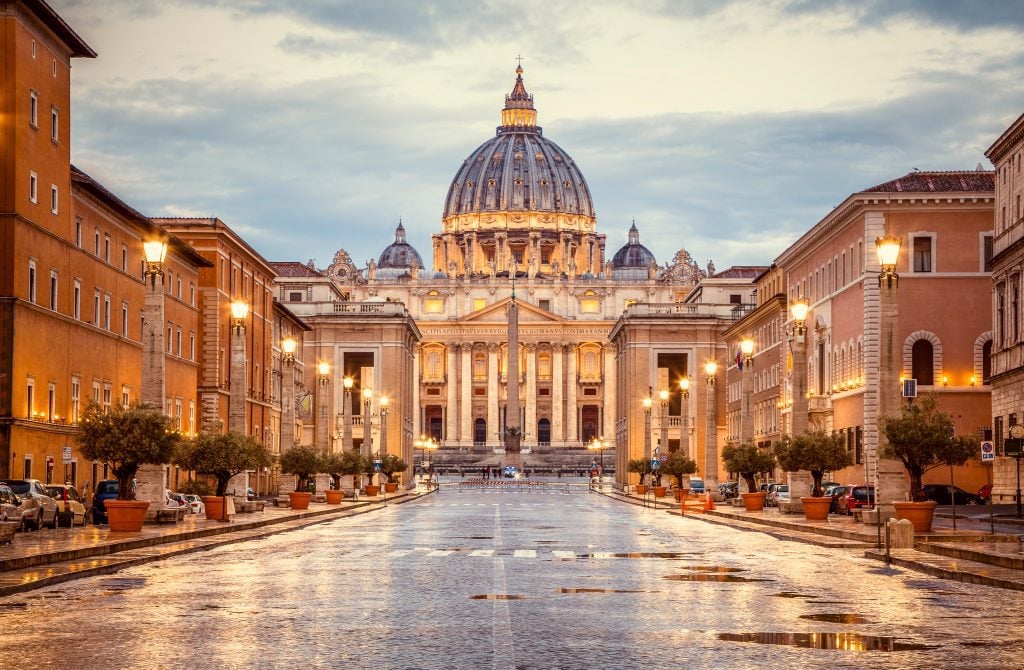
(0, 492, 1024, 669)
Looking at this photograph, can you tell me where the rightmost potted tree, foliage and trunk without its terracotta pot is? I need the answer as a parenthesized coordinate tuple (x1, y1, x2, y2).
(882, 393, 977, 501)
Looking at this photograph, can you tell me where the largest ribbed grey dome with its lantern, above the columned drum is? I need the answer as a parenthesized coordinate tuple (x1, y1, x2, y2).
(443, 68, 594, 219)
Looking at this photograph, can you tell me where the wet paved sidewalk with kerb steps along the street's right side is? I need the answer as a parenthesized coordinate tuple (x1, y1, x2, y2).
(600, 490, 1024, 591)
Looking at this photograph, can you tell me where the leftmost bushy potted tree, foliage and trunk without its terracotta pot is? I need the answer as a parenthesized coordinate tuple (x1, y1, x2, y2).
(78, 403, 181, 500)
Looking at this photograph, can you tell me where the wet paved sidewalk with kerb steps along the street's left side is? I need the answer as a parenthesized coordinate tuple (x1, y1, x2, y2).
(0, 490, 427, 597)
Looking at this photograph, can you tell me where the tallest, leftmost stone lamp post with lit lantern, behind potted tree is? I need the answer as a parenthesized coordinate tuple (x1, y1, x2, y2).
(135, 238, 167, 513)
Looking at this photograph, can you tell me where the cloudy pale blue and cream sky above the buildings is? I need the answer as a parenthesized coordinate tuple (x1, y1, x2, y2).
(56, 0, 1024, 269)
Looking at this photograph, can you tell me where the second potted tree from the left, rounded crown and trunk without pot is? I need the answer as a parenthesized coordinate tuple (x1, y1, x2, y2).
(175, 430, 271, 496)
